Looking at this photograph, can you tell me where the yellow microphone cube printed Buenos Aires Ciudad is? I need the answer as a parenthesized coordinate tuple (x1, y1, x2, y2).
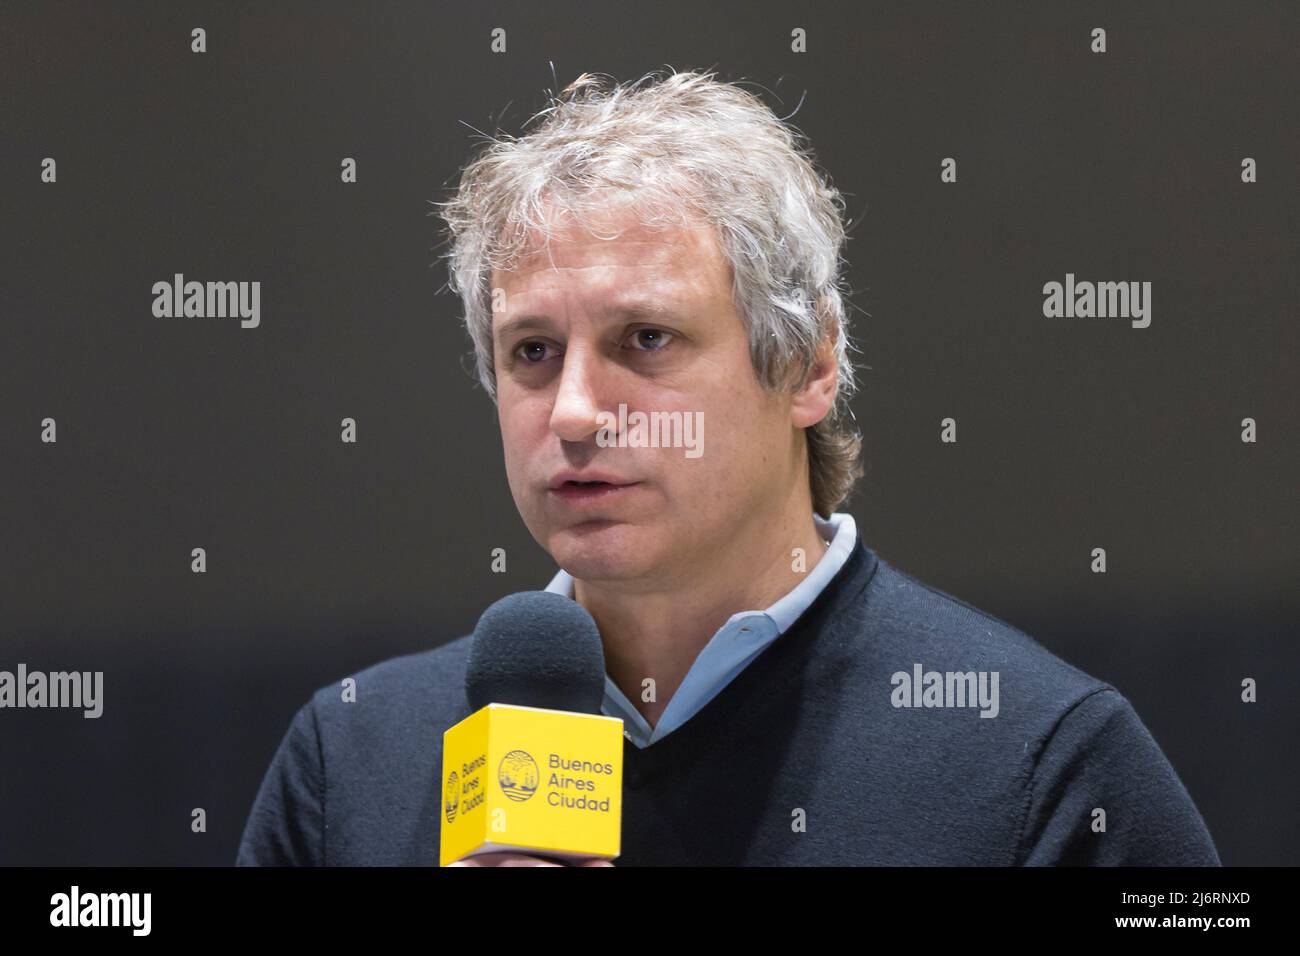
(438, 704, 623, 866)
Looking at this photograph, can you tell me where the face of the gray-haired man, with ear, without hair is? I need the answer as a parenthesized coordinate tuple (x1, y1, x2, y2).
(491, 209, 803, 591)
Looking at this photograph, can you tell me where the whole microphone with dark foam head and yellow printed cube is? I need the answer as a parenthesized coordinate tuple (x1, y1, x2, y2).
(438, 591, 623, 866)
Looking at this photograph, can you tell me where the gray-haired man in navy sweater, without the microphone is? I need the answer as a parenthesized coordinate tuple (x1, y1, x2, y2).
(238, 73, 1218, 865)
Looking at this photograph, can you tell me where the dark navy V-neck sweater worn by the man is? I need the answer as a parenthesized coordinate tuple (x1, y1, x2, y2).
(237, 540, 1219, 866)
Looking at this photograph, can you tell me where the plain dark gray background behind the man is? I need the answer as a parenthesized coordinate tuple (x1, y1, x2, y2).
(0, 1, 1300, 865)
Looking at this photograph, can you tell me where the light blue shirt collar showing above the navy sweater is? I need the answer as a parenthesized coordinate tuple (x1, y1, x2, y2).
(546, 511, 858, 748)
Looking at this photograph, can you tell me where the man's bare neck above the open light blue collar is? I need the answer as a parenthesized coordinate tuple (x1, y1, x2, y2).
(573, 507, 827, 727)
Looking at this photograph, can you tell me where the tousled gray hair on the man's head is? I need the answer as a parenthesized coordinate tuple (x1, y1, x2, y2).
(430, 72, 862, 518)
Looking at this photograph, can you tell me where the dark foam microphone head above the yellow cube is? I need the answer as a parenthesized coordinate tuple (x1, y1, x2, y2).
(465, 591, 605, 714)
